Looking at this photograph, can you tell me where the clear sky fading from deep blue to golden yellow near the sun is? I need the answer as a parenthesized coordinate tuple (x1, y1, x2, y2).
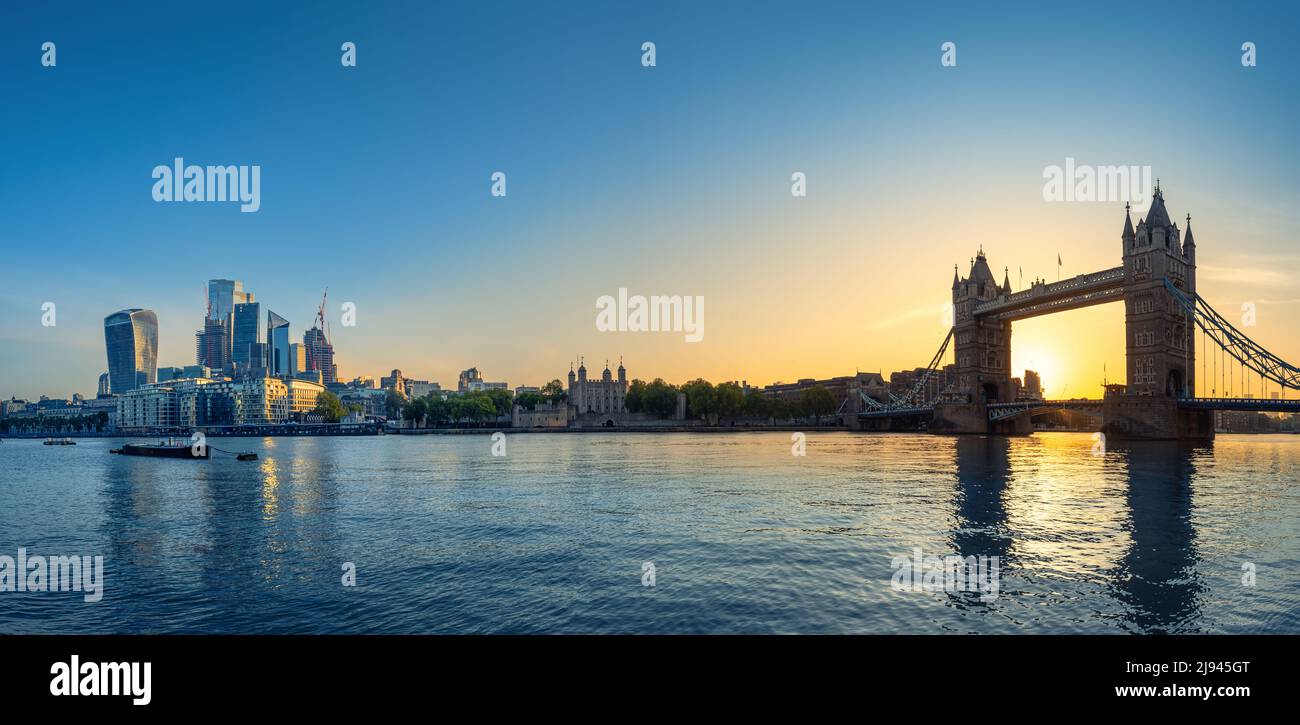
(0, 1, 1300, 396)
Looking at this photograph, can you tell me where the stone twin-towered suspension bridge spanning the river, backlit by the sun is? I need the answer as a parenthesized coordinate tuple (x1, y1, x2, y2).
(858, 183, 1300, 439)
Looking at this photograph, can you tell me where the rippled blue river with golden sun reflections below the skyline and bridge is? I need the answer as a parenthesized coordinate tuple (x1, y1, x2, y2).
(0, 431, 1300, 633)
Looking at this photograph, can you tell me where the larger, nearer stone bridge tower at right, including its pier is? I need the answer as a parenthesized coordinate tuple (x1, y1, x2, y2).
(1104, 181, 1214, 438)
